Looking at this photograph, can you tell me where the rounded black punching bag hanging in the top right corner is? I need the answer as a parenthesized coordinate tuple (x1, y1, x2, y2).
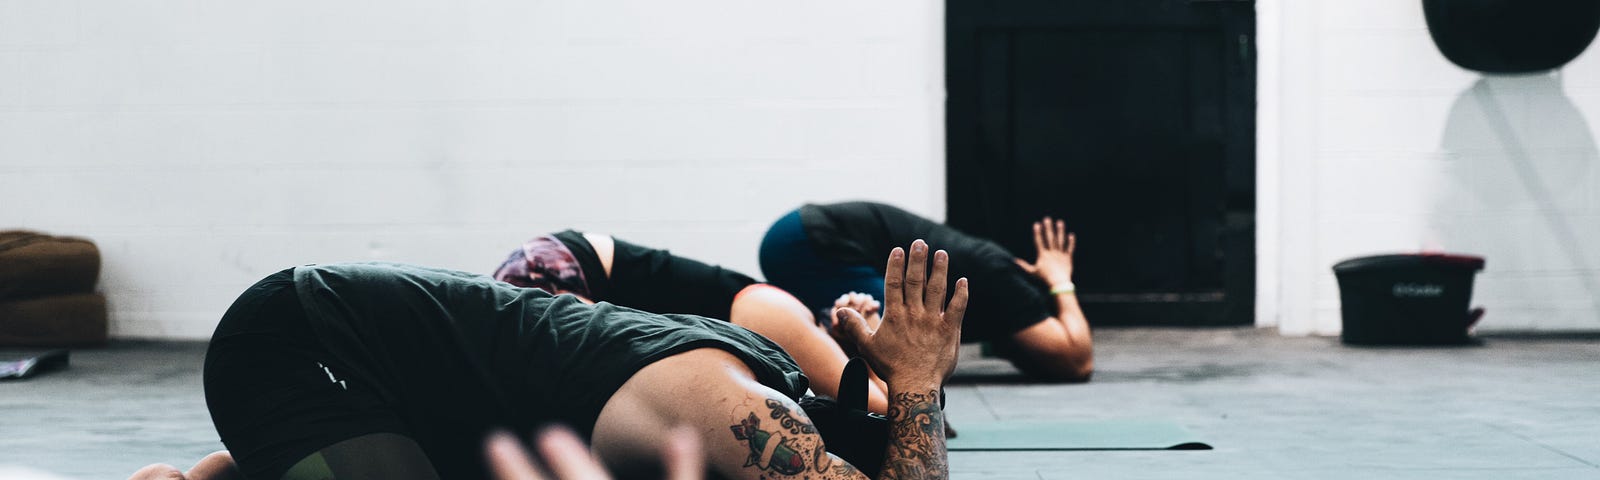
(1422, 0, 1600, 74)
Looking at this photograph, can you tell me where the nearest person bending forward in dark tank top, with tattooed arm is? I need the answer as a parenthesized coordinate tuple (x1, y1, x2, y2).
(184, 242, 968, 480)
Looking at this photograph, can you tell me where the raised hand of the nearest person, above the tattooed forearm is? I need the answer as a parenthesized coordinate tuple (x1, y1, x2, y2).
(835, 240, 968, 390)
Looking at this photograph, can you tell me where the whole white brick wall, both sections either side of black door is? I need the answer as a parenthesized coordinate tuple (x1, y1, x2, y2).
(12, 0, 1600, 338)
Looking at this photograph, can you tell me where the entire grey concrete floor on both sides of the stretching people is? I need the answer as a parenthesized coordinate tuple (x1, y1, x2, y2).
(0, 330, 1600, 480)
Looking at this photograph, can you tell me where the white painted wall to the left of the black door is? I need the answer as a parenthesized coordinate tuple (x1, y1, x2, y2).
(0, 0, 944, 338)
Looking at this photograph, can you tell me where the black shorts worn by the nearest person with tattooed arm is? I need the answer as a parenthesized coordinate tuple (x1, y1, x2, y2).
(205, 269, 499, 478)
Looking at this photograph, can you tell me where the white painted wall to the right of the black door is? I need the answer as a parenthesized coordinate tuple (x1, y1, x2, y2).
(1258, 0, 1600, 334)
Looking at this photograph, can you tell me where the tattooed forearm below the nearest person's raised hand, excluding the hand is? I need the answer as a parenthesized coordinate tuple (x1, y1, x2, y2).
(878, 382, 950, 480)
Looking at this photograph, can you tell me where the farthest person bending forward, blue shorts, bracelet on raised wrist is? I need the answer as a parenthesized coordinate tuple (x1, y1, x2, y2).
(760, 202, 1094, 381)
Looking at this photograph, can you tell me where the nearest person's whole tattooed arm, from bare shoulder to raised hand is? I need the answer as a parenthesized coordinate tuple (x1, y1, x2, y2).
(592, 240, 966, 480)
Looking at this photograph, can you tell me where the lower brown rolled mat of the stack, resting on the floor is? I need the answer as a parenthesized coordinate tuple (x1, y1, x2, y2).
(0, 293, 106, 347)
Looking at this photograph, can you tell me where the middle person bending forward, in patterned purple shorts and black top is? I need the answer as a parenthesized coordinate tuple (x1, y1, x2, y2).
(493, 230, 889, 413)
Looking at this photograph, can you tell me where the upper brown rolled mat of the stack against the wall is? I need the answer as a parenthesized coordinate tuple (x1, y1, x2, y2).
(0, 230, 101, 301)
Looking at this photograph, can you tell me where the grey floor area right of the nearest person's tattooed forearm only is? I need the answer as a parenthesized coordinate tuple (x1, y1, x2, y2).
(949, 330, 1600, 480)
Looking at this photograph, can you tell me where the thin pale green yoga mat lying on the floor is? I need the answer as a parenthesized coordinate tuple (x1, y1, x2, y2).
(946, 419, 1211, 451)
